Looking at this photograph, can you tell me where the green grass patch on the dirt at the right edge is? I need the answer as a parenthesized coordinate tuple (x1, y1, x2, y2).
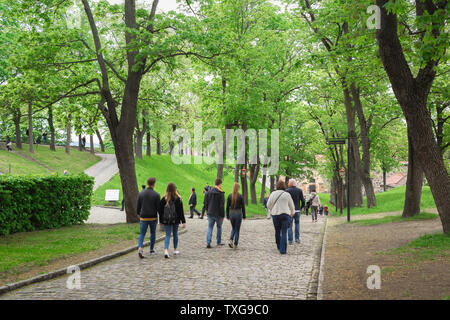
(387, 233, 450, 263)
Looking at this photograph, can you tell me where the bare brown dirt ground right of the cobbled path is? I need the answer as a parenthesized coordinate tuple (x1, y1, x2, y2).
(322, 213, 450, 300)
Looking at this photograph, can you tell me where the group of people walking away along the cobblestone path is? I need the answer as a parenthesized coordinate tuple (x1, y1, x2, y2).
(137, 178, 321, 258)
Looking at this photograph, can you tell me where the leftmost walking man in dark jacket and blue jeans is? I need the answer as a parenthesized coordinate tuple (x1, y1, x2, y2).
(137, 178, 161, 259)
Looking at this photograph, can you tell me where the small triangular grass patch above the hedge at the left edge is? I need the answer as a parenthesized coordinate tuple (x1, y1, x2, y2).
(0, 150, 50, 175)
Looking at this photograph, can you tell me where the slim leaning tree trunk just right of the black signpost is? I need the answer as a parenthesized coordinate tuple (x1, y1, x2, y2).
(351, 83, 377, 208)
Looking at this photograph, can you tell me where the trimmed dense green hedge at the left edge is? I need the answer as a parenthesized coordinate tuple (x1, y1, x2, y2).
(0, 173, 94, 235)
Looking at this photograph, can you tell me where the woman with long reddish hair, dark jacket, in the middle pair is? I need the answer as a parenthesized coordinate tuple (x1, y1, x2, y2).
(227, 182, 245, 249)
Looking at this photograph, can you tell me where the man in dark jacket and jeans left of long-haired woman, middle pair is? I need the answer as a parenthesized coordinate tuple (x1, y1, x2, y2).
(204, 179, 225, 248)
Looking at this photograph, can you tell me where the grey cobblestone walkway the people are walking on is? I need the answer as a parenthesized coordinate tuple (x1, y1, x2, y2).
(0, 216, 325, 300)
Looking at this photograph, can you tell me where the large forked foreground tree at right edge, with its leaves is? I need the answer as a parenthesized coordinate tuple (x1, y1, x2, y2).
(377, 0, 450, 233)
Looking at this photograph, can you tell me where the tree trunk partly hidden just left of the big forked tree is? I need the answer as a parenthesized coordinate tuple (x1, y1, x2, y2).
(402, 130, 423, 218)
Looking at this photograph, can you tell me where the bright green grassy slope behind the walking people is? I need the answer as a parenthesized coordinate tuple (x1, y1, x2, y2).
(94, 155, 265, 216)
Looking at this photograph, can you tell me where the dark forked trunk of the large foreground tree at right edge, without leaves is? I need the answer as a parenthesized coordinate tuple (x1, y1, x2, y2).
(377, 0, 450, 234)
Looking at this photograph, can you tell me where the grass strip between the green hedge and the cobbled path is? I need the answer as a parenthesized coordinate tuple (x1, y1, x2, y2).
(0, 224, 139, 272)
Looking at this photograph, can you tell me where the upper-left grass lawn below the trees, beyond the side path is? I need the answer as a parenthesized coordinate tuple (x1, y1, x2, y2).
(16, 144, 100, 173)
